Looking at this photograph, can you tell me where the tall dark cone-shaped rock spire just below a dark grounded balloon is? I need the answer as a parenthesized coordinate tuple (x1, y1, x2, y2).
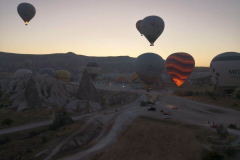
(76, 69, 99, 102)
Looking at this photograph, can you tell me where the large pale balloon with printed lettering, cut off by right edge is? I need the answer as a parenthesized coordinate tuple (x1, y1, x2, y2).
(210, 52, 240, 94)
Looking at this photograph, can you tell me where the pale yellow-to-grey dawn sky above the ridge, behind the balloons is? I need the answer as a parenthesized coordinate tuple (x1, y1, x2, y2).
(0, 0, 240, 67)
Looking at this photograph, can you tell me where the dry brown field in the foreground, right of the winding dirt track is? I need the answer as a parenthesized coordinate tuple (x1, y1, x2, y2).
(96, 117, 203, 160)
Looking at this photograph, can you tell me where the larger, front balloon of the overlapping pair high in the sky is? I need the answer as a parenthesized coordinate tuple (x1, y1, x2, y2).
(140, 16, 165, 46)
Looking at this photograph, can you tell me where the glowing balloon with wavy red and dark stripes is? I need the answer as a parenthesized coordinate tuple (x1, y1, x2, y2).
(165, 52, 195, 87)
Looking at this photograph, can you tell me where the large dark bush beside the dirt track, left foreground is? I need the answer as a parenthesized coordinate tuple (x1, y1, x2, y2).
(49, 111, 73, 130)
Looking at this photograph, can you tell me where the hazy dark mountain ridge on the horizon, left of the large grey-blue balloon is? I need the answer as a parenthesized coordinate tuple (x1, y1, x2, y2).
(0, 52, 136, 74)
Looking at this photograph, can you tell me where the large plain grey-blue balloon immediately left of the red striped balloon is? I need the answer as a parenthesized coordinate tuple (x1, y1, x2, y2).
(135, 53, 164, 91)
